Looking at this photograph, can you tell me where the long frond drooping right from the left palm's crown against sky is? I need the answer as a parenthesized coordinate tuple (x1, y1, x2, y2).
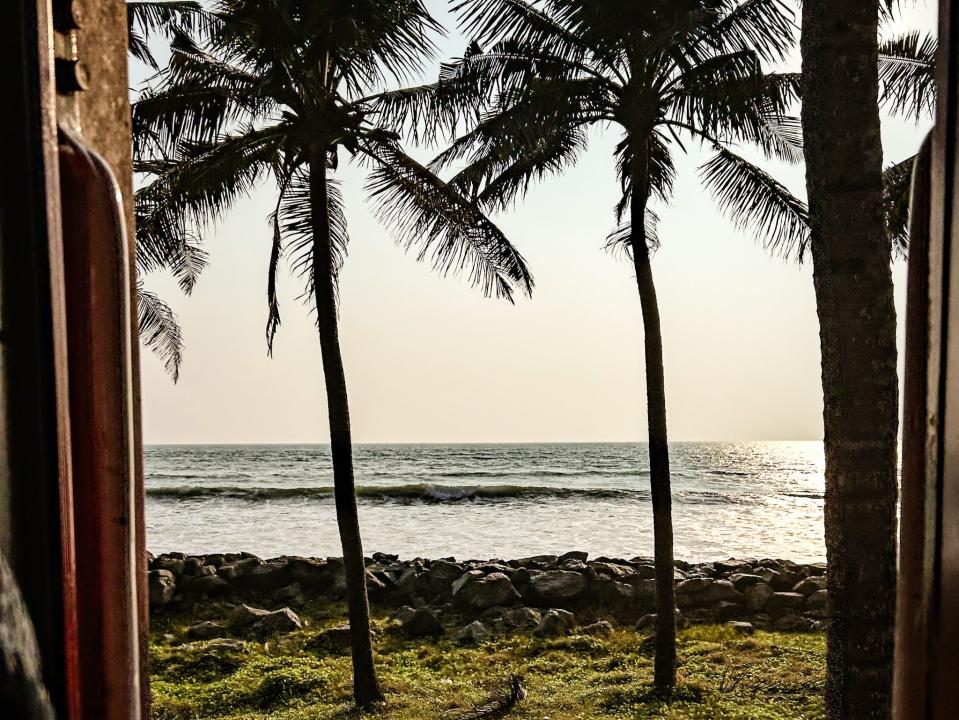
(363, 142, 533, 301)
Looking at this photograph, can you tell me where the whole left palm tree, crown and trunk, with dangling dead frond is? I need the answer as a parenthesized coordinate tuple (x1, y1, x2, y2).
(134, 0, 532, 706)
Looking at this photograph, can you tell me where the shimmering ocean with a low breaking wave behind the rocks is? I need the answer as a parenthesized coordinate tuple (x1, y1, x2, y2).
(145, 442, 825, 562)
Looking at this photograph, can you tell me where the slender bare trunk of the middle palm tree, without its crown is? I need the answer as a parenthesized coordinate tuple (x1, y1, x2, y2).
(630, 147, 676, 690)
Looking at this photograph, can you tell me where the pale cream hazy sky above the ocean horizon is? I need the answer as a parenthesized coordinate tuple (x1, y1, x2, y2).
(131, 0, 935, 443)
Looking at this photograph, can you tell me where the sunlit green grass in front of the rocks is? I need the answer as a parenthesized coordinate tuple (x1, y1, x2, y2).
(150, 605, 825, 720)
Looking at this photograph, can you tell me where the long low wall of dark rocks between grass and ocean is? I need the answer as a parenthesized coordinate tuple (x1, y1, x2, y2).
(149, 552, 830, 642)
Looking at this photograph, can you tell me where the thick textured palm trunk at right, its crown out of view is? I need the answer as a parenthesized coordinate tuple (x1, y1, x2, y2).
(801, 0, 899, 720)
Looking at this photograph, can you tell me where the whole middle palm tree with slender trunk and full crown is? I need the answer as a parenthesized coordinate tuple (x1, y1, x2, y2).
(404, 0, 805, 689)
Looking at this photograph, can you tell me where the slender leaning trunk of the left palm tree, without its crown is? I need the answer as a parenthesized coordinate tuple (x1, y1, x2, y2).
(310, 149, 383, 707)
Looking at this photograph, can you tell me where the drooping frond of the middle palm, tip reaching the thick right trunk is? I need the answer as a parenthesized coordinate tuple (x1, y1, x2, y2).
(700, 147, 809, 260)
